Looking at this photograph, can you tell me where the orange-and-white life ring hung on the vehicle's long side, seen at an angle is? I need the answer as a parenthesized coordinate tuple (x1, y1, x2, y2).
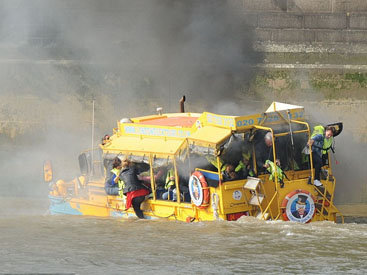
(189, 171, 210, 209)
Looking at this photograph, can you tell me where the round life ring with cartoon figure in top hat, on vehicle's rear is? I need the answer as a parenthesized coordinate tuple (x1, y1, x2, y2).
(281, 189, 316, 223)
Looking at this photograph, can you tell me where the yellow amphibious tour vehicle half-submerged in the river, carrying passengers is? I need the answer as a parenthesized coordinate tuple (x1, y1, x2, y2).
(44, 102, 342, 223)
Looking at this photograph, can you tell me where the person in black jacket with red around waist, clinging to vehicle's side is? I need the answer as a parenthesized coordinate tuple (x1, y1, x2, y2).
(120, 157, 149, 219)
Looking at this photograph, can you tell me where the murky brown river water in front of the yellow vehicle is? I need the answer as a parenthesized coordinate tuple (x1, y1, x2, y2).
(0, 198, 367, 274)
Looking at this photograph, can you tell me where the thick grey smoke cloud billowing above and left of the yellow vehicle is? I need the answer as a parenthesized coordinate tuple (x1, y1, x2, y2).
(0, 0, 262, 196)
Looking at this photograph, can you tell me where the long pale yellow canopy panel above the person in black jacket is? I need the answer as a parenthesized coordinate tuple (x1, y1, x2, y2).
(103, 136, 184, 155)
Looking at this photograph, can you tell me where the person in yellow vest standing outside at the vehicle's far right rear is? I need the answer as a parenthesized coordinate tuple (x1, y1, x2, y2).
(307, 125, 336, 187)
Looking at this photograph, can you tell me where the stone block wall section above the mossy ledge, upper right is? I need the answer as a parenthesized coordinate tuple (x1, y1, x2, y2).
(243, 0, 367, 53)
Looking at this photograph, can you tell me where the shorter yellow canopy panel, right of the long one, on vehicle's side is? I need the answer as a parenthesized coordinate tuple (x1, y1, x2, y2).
(188, 126, 232, 145)
